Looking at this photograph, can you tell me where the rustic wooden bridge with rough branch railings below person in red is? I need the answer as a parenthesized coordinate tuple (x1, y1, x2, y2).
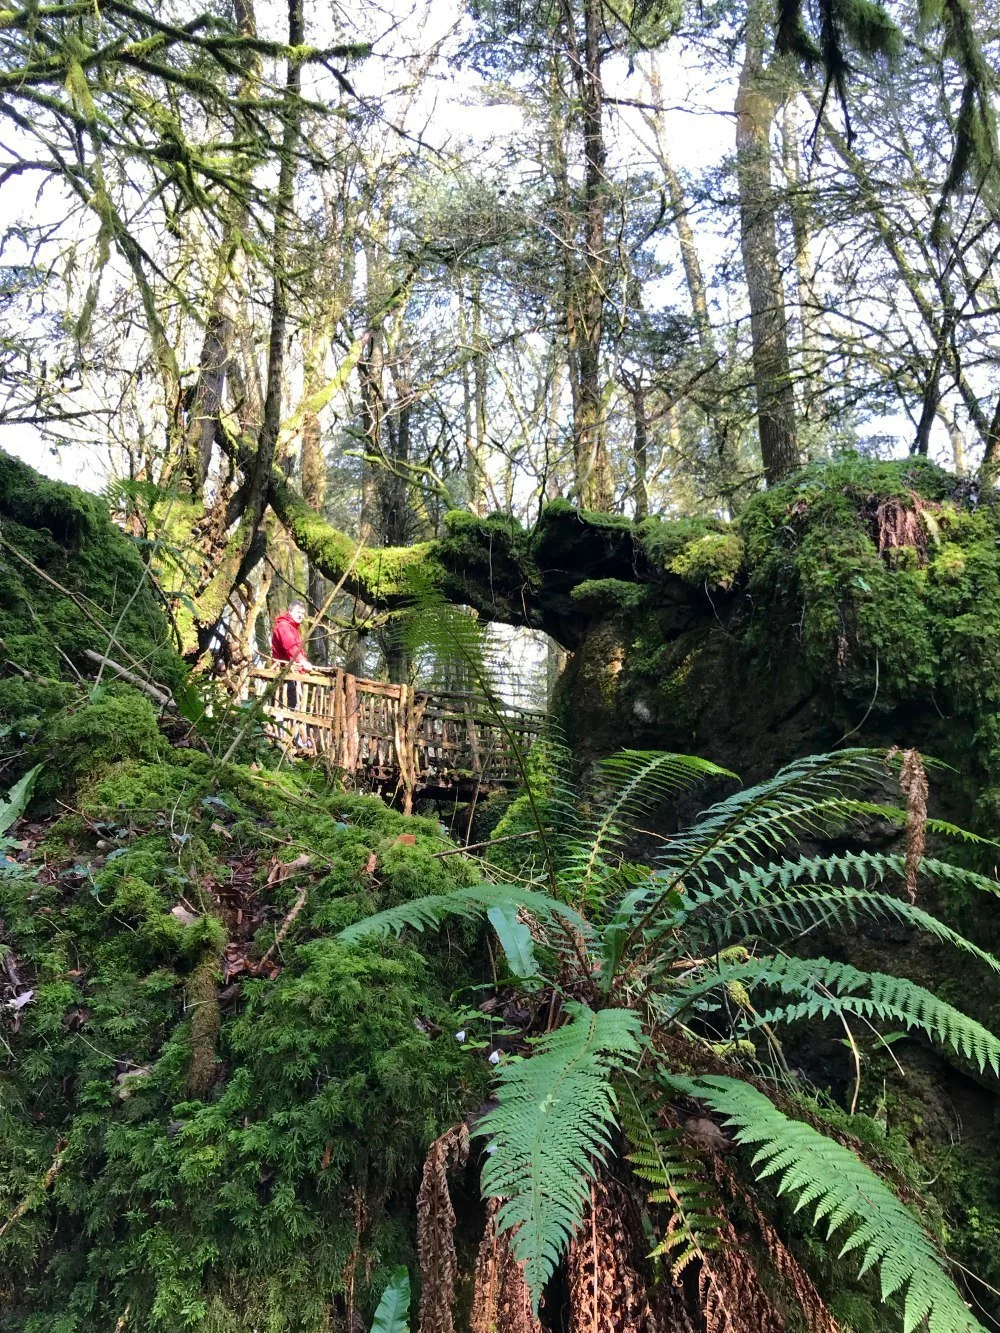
(251, 667, 545, 810)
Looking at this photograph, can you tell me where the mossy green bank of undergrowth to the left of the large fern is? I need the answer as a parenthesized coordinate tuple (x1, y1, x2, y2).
(0, 751, 488, 1333)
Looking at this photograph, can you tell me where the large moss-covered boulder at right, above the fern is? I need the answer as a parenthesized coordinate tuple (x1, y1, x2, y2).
(563, 456, 1000, 833)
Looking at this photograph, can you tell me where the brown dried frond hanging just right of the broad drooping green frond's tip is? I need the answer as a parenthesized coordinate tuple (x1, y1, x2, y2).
(567, 1180, 660, 1333)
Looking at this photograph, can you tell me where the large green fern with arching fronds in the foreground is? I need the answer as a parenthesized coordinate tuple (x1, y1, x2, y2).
(341, 750, 1000, 1333)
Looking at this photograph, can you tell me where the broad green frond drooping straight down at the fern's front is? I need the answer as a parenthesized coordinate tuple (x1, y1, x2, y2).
(476, 1002, 641, 1310)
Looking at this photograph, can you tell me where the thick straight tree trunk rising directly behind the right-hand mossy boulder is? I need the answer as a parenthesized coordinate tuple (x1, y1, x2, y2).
(736, 0, 799, 485)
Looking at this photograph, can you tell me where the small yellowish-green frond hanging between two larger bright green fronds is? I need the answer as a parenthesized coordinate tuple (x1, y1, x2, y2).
(619, 1078, 724, 1280)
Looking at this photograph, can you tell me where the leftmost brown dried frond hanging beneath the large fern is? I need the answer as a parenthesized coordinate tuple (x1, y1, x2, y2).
(417, 1124, 469, 1333)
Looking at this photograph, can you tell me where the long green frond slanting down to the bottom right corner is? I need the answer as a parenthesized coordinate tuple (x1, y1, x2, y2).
(665, 1076, 984, 1333)
